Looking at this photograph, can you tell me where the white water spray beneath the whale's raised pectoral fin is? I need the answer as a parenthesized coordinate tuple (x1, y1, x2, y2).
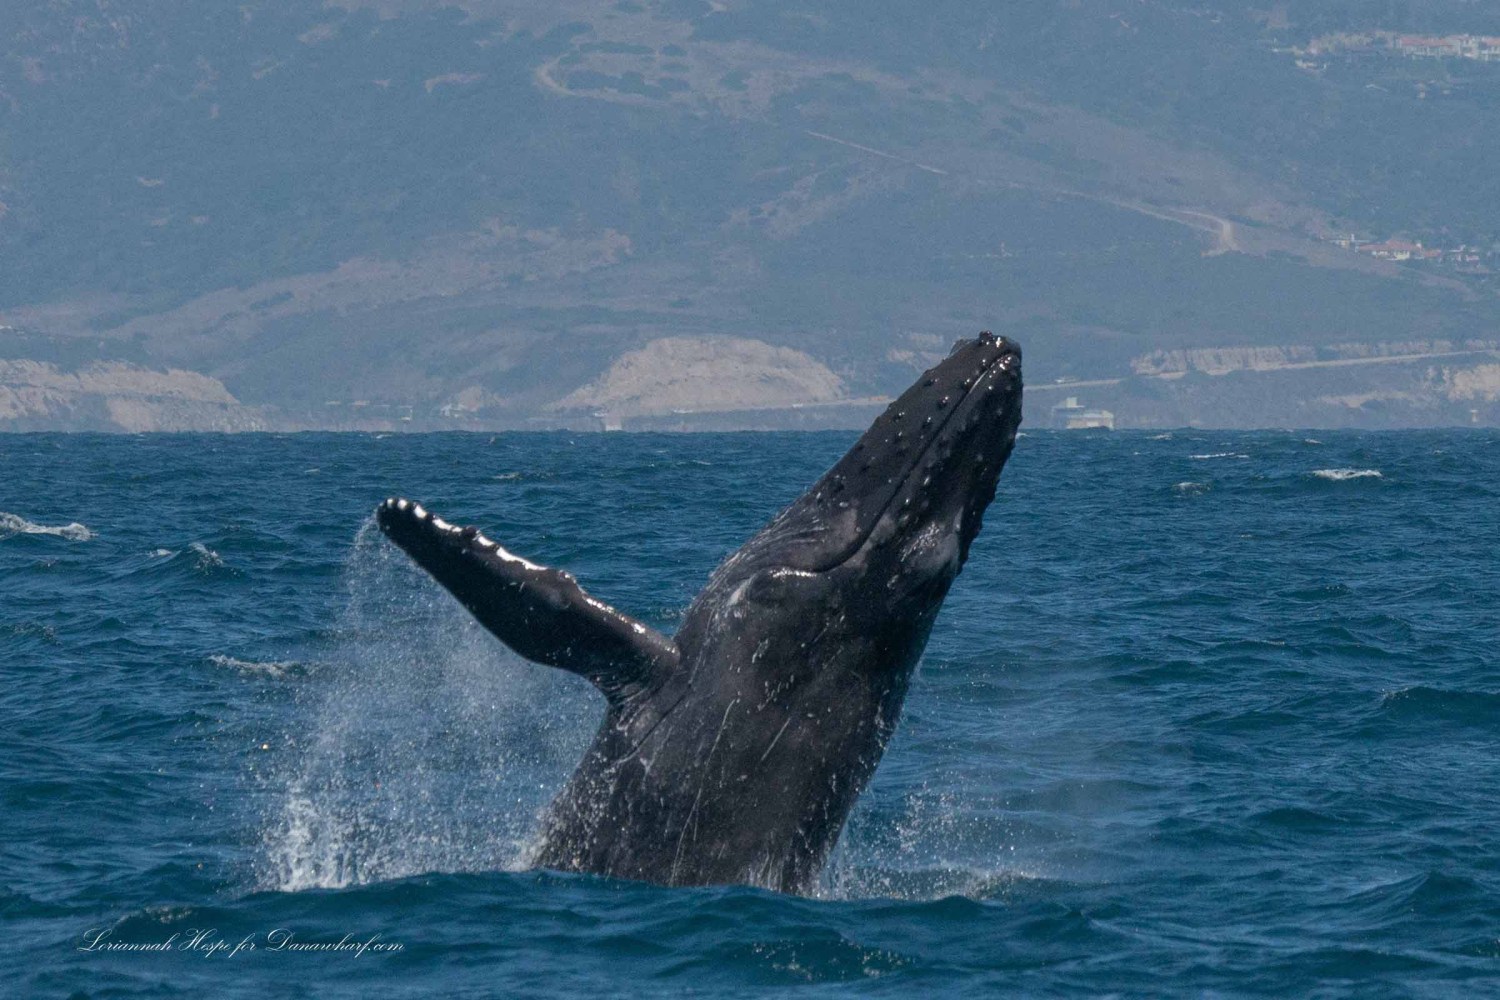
(258, 519, 600, 891)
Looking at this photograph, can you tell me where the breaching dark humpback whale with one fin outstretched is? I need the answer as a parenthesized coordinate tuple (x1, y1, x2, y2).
(377, 333, 1022, 892)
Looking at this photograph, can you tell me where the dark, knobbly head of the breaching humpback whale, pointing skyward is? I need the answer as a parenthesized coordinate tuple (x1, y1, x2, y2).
(684, 333, 1022, 668)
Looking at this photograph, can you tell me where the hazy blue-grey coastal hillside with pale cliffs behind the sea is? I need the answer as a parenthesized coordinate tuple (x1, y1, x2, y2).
(0, 0, 1500, 430)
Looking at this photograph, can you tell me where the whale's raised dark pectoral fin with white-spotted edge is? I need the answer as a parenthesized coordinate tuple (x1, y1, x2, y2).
(375, 499, 678, 703)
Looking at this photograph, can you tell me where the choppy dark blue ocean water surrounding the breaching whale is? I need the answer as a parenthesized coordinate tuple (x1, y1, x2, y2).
(0, 430, 1500, 999)
